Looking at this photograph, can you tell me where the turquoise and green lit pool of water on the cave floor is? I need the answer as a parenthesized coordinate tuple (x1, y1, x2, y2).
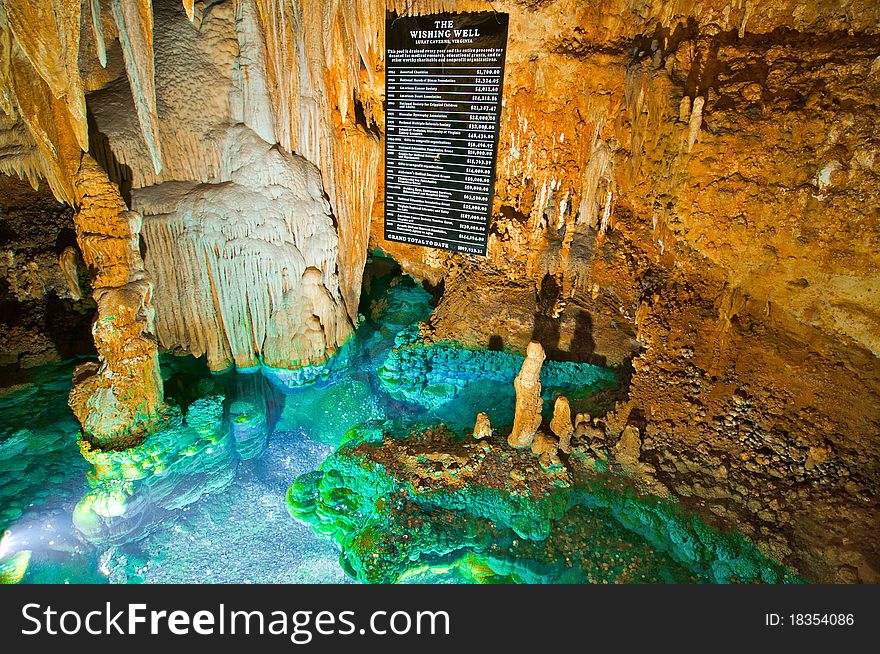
(0, 262, 796, 583)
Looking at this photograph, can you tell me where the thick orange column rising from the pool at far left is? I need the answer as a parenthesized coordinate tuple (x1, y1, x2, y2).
(70, 154, 163, 446)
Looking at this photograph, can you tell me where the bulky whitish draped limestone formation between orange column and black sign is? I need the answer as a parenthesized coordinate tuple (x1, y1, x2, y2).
(133, 127, 353, 370)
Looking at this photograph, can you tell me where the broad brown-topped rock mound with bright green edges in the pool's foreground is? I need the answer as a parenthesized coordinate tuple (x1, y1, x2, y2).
(287, 422, 796, 583)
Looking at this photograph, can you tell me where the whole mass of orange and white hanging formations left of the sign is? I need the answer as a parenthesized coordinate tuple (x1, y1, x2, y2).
(0, 0, 381, 441)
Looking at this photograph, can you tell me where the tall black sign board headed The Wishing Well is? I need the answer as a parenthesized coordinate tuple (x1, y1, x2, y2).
(385, 12, 508, 255)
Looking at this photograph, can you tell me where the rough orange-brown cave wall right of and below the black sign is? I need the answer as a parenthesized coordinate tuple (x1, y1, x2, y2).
(360, 0, 880, 582)
